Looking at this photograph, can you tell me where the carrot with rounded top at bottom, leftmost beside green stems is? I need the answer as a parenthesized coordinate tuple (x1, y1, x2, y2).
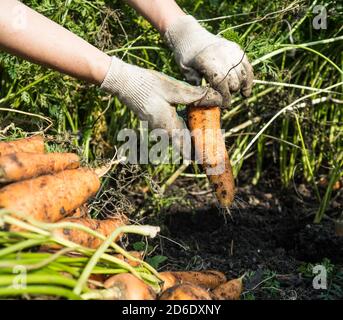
(104, 273, 156, 300)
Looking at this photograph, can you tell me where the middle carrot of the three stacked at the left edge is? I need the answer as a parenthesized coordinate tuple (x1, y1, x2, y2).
(0, 152, 80, 183)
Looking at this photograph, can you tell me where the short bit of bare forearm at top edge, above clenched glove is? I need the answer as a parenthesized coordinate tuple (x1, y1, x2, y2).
(126, 0, 185, 34)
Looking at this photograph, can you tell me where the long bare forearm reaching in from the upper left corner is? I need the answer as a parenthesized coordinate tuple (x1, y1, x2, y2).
(0, 0, 111, 84)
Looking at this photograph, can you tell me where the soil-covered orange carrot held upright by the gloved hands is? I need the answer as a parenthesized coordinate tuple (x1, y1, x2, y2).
(188, 106, 235, 207)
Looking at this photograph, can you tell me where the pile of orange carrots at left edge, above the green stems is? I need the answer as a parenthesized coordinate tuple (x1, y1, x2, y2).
(0, 135, 127, 242)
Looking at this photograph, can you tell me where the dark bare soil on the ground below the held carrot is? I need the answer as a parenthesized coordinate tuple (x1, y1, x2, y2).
(140, 170, 343, 299)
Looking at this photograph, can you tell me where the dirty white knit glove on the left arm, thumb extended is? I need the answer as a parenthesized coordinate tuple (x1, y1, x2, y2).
(101, 57, 222, 134)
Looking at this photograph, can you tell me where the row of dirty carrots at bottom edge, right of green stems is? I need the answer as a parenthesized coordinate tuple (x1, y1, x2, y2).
(88, 270, 243, 300)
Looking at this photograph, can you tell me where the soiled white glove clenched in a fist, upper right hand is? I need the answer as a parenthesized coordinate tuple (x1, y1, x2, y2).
(164, 16, 254, 107)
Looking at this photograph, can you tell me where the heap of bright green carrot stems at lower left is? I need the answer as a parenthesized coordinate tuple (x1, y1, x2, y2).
(0, 209, 162, 300)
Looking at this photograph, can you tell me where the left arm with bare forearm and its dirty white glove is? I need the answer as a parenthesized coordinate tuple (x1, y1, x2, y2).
(0, 0, 222, 133)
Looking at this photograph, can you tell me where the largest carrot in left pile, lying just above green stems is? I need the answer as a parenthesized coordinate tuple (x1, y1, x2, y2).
(0, 168, 100, 228)
